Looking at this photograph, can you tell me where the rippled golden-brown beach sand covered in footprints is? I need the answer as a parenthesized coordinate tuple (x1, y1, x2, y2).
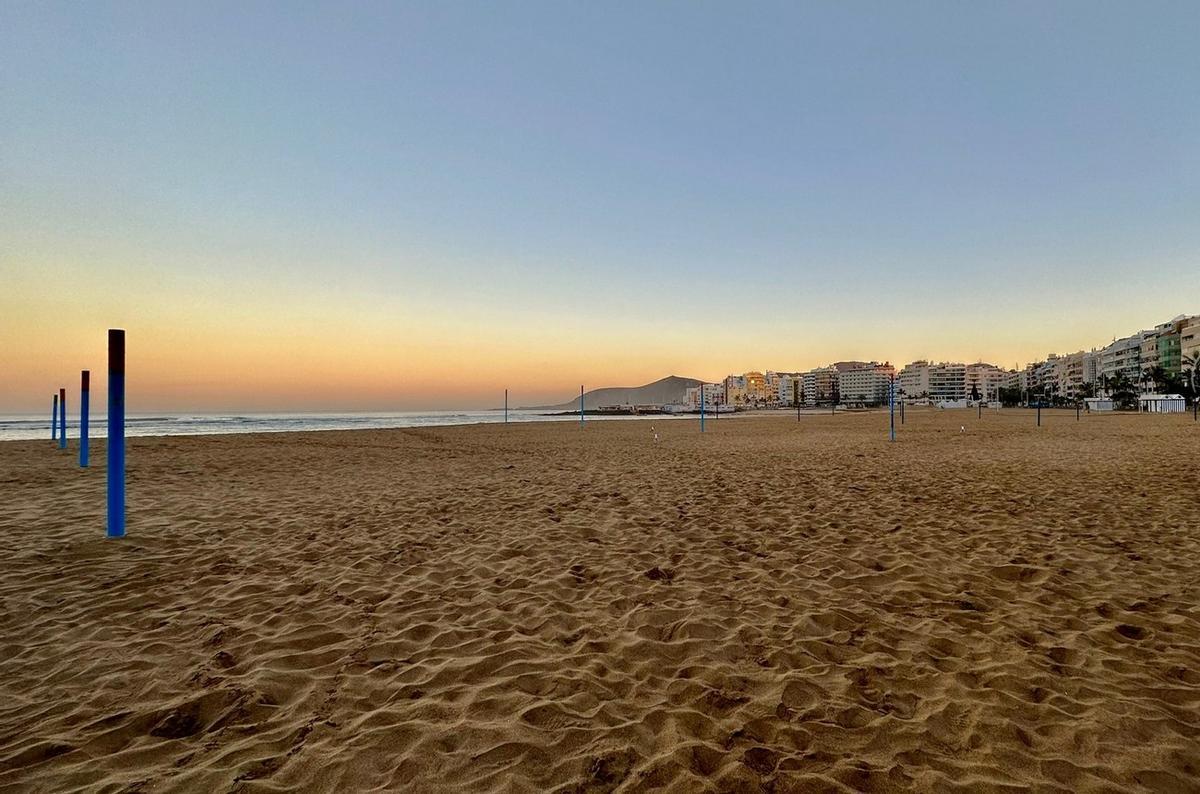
(0, 410, 1200, 792)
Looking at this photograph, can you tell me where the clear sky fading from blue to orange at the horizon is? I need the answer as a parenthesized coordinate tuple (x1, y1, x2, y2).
(0, 0, 1200, 413)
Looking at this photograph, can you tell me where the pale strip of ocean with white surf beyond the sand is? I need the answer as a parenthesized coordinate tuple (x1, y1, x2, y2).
(0, 409, 695, 441)
